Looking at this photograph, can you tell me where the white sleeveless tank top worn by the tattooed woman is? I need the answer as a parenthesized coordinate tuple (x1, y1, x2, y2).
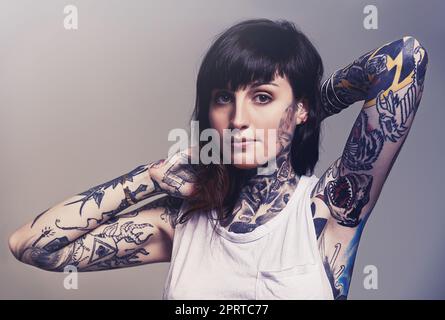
(163, 175, 333, 300)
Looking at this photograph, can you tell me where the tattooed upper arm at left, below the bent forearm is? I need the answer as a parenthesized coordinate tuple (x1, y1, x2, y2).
(14, 196, 183, 271)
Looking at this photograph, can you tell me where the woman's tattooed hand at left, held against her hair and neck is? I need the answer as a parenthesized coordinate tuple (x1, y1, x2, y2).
(148, 148, 196, 198)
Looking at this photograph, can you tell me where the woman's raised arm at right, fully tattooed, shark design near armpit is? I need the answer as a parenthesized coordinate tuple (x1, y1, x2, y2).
(312, 37, 428, 299)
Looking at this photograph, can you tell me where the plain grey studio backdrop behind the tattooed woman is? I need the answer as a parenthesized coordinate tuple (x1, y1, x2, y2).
(0, 0, 445, 299)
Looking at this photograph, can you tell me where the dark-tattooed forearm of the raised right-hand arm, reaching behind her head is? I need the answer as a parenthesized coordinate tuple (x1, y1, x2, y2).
(320, 37, 428, 116)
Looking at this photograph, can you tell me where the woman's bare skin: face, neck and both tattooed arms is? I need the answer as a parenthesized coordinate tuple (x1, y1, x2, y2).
(9, 37, 428, 299)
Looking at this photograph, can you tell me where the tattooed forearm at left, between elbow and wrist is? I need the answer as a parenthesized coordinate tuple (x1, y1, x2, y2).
(10, 165, 168, 269)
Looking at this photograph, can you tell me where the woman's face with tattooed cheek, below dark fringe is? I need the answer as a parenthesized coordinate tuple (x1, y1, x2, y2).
(209, 76, 307, 169)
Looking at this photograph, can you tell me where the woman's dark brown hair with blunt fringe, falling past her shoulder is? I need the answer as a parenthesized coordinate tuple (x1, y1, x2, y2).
(176, 19, 323, 223)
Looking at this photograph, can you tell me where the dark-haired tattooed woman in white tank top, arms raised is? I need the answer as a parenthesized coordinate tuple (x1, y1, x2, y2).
(9, 19, 428, 299)
